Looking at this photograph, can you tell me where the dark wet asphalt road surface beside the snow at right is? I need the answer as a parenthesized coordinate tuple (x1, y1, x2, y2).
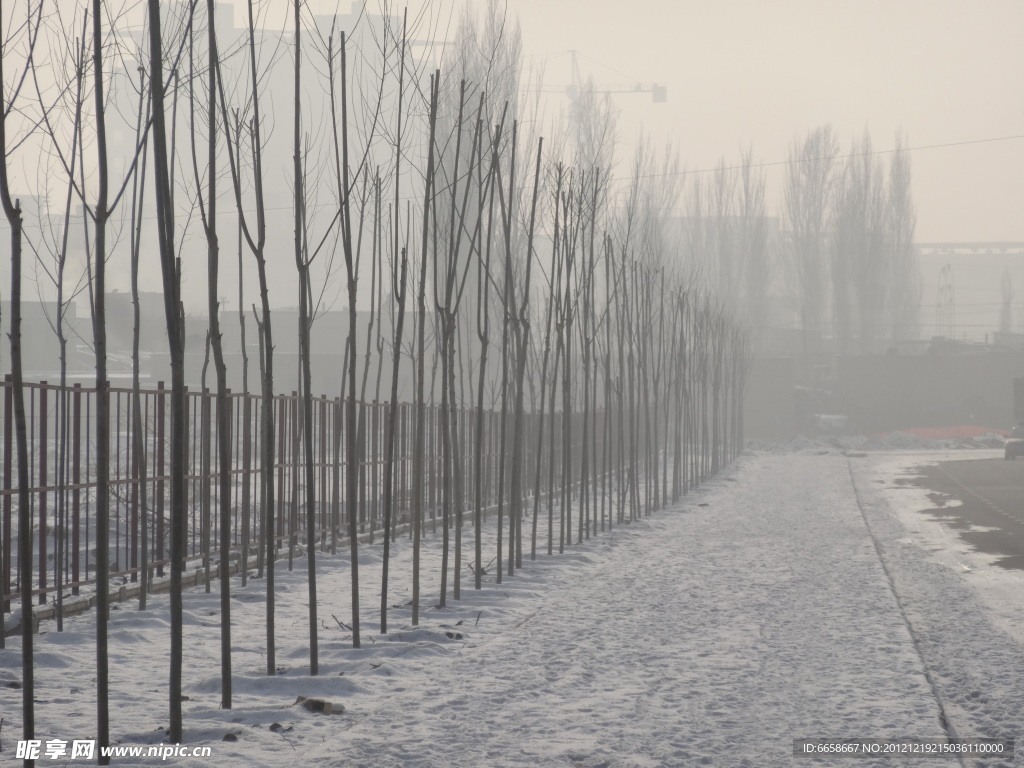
(903, 457, 1024, 570)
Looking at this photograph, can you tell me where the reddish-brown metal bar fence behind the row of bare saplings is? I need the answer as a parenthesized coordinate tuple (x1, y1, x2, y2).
(0, 376, 615, 612)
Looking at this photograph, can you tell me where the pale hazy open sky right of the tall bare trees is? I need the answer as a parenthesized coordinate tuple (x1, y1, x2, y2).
(493, 0, 1024, 241)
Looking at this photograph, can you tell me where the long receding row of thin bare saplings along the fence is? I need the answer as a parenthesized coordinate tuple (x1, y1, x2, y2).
(0, 0, 763, 761)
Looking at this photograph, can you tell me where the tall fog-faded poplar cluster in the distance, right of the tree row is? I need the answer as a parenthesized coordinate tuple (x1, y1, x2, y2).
(780, 125, 922, 353)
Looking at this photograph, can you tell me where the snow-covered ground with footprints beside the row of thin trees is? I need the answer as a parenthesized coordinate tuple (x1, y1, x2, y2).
(0, 444, 1024, 768)
